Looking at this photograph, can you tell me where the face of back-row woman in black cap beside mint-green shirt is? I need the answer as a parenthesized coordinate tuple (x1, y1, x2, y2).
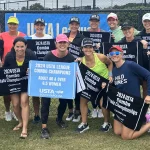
(122, 27, 134, 38)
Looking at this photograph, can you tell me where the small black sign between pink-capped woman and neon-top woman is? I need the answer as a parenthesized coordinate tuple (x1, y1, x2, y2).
(68, 43, 83, 58)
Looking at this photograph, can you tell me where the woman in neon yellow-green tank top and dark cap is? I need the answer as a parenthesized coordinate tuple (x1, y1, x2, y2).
(77, 38, 113, 133)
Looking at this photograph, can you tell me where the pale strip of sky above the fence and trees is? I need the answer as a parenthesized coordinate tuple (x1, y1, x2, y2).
(0, 0, 150, 9)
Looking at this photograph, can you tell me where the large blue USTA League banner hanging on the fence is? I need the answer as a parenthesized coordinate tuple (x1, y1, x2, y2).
(5, 13, 109, 38)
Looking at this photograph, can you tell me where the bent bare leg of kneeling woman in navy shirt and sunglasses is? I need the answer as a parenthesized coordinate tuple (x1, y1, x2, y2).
(121, 122, 150, 140)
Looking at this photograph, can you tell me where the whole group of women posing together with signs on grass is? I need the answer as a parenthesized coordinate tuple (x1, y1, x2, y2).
(0, 13, 150, 139)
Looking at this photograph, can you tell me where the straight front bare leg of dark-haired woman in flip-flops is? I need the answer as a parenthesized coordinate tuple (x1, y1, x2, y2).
(20, 92, 29, 134)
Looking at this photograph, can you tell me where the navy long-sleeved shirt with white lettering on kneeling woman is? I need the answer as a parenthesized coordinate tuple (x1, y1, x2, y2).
(113, 60, 150, 97)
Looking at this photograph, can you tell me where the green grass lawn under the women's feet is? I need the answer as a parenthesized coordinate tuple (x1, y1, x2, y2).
(0, 98, 150, 150)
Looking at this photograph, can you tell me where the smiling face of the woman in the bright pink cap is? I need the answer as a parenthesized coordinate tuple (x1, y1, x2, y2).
(56, 41, 69, 52)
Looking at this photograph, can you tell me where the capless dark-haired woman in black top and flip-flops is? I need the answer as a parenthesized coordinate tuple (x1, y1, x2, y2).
(3, 37, 36, 138)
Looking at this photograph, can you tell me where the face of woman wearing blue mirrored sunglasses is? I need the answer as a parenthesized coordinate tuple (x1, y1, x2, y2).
(109, 49, 123, 63)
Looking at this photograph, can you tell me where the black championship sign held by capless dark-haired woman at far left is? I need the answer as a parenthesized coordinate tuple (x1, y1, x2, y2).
(0, 67, 28, 96)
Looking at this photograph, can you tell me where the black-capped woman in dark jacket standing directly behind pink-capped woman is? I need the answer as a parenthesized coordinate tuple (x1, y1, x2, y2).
(65, 17, 84, 122)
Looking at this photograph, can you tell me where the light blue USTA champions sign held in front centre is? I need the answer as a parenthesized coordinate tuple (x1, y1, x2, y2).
(28, 61, 77, 99)
